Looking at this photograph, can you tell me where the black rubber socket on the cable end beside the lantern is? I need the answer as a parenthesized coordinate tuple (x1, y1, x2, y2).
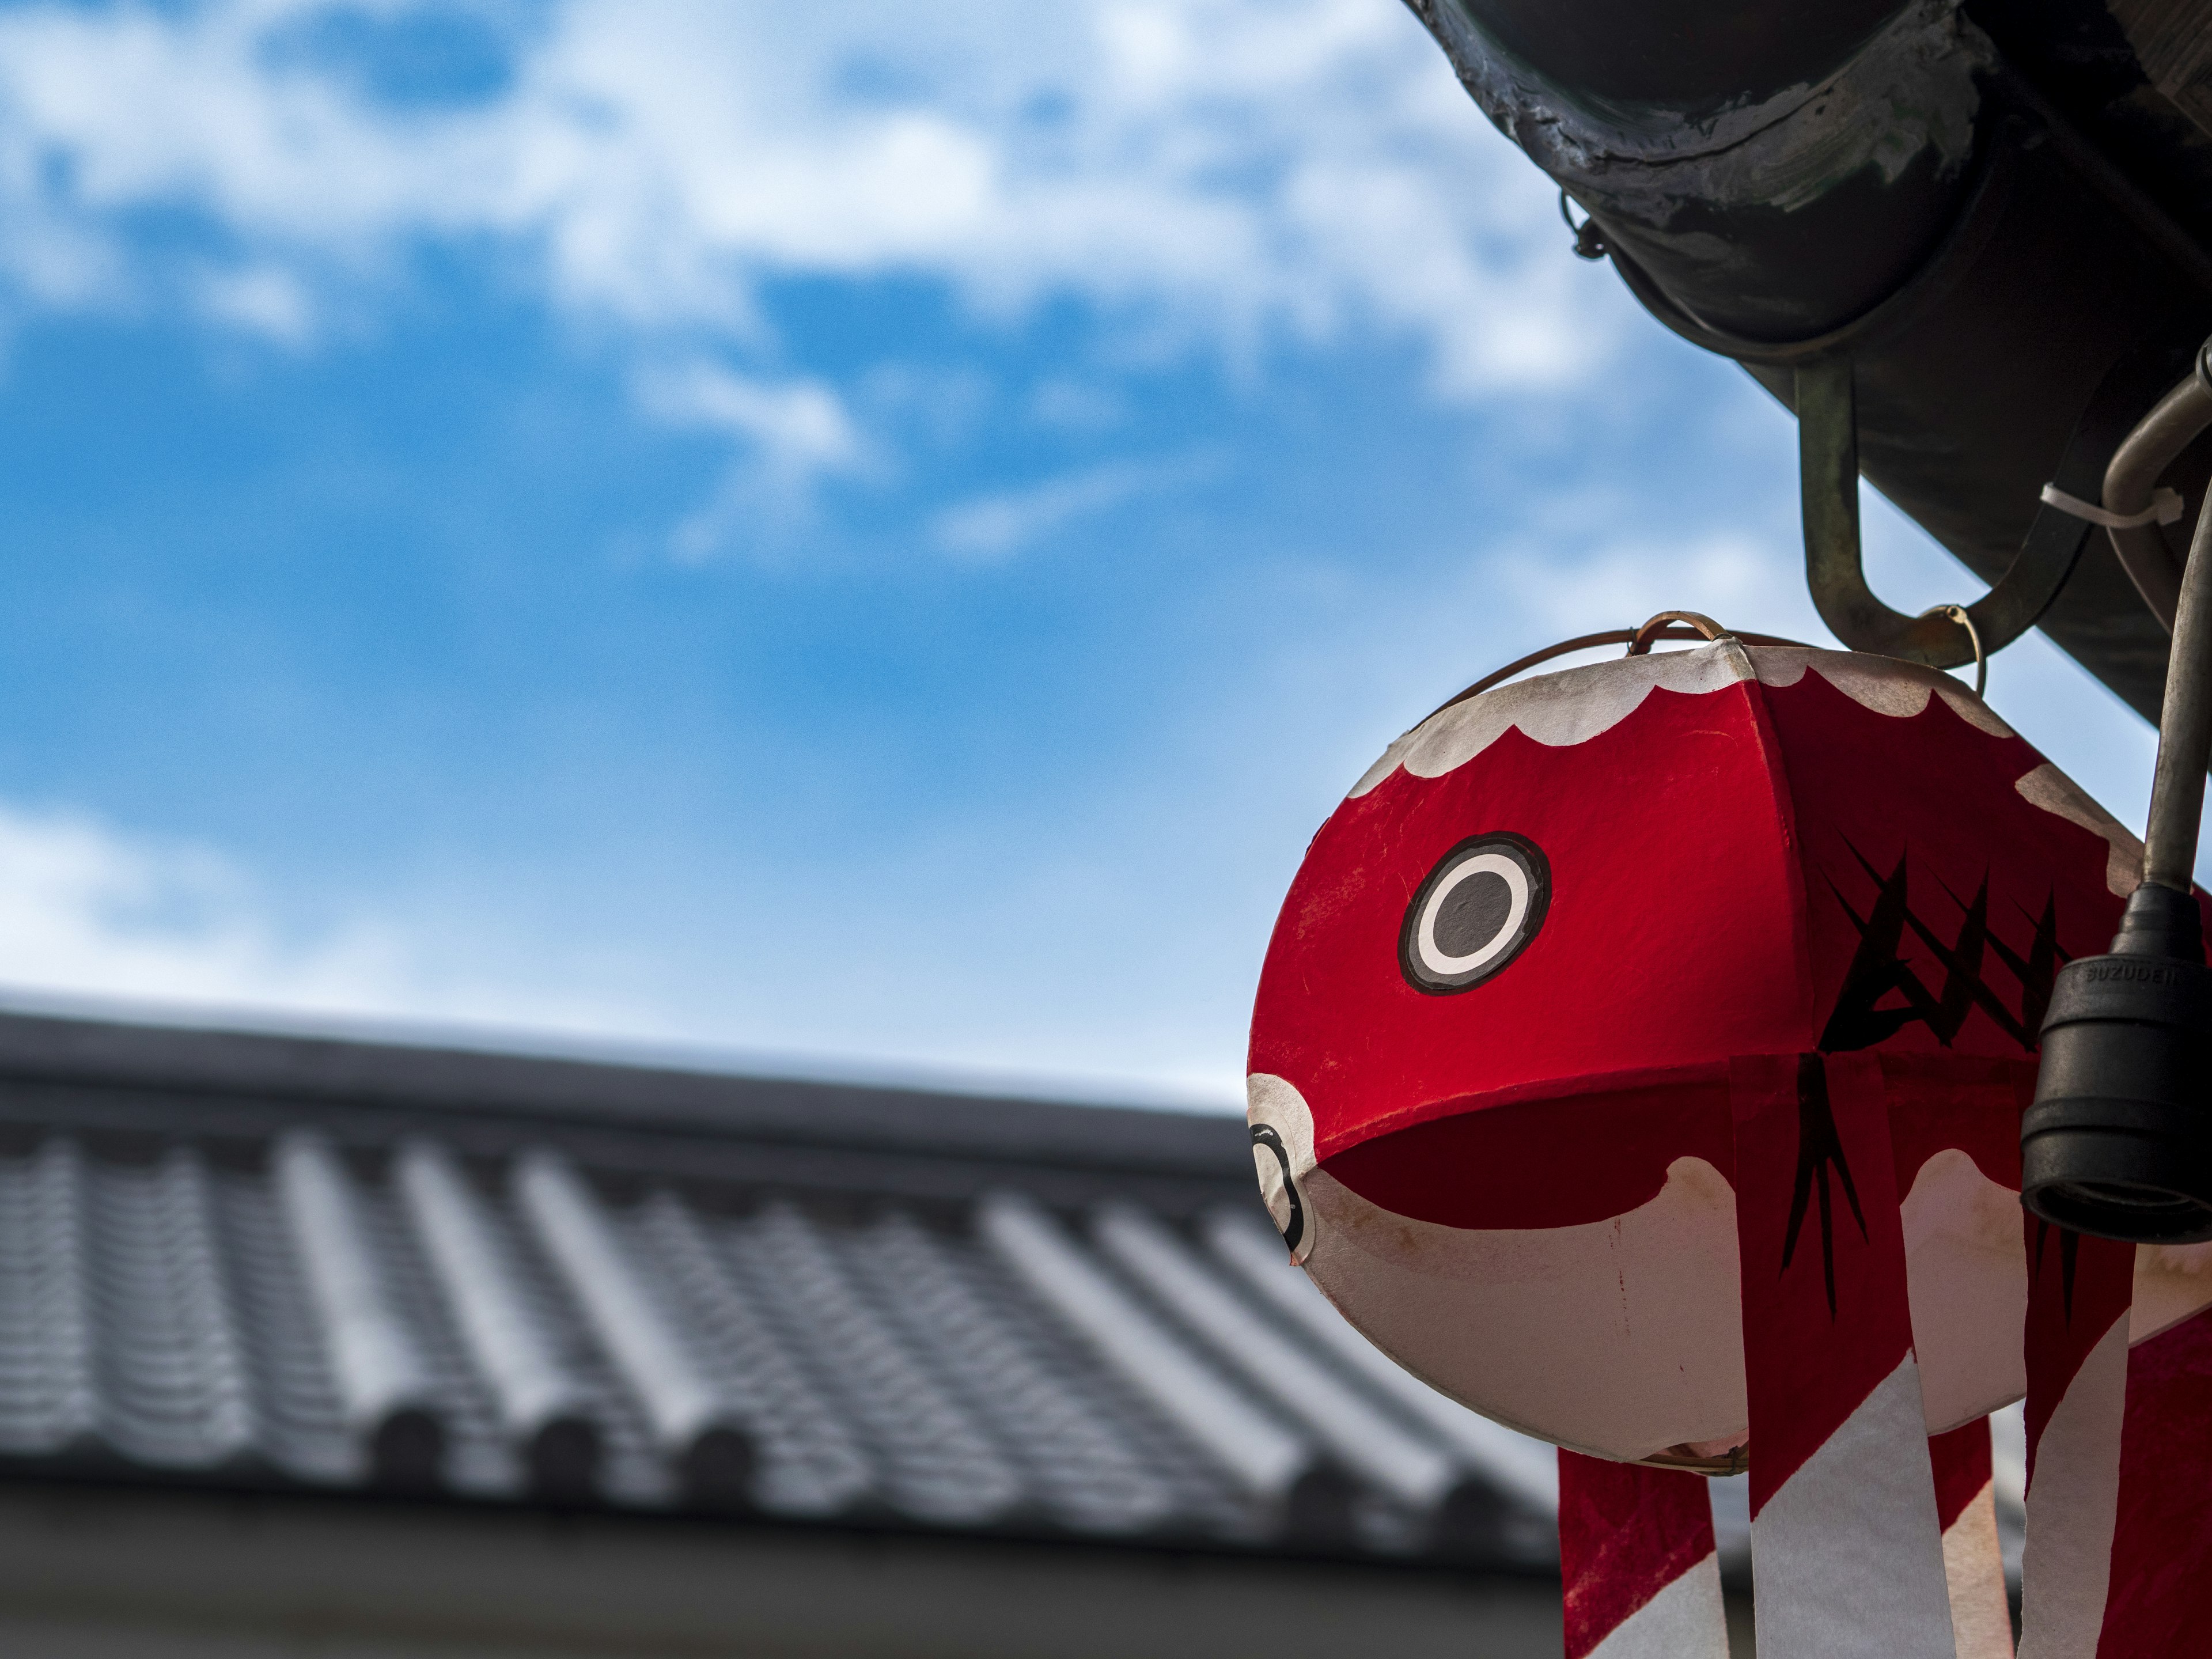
(2020, 885, 2212, 1243)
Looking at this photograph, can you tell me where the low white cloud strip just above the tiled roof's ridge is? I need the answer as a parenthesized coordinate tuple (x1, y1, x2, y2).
(0, 803, 1241, 1104)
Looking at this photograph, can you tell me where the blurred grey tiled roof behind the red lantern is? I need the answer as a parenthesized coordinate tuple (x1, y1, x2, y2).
(0, 1016, 1553, 1564)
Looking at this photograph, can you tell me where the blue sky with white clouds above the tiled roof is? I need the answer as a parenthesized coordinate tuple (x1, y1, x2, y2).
(0, 0, 2152, 1119)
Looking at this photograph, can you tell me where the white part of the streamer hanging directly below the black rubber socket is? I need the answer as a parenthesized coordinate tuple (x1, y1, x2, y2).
(2020, 1314, 2128, 1659)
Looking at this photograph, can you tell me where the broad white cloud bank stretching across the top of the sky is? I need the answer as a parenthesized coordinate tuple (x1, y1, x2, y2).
(0, 0, 1612, 396)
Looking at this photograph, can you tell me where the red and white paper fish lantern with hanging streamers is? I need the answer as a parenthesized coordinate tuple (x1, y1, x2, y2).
(1250, 639, 2212, 1659)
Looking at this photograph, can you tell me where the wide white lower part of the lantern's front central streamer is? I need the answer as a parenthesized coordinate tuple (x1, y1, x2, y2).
(1752, 1354, 1957, 1659)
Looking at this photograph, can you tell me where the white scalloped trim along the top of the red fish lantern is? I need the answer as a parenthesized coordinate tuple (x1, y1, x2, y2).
(1351, 639, 2013, 798)
